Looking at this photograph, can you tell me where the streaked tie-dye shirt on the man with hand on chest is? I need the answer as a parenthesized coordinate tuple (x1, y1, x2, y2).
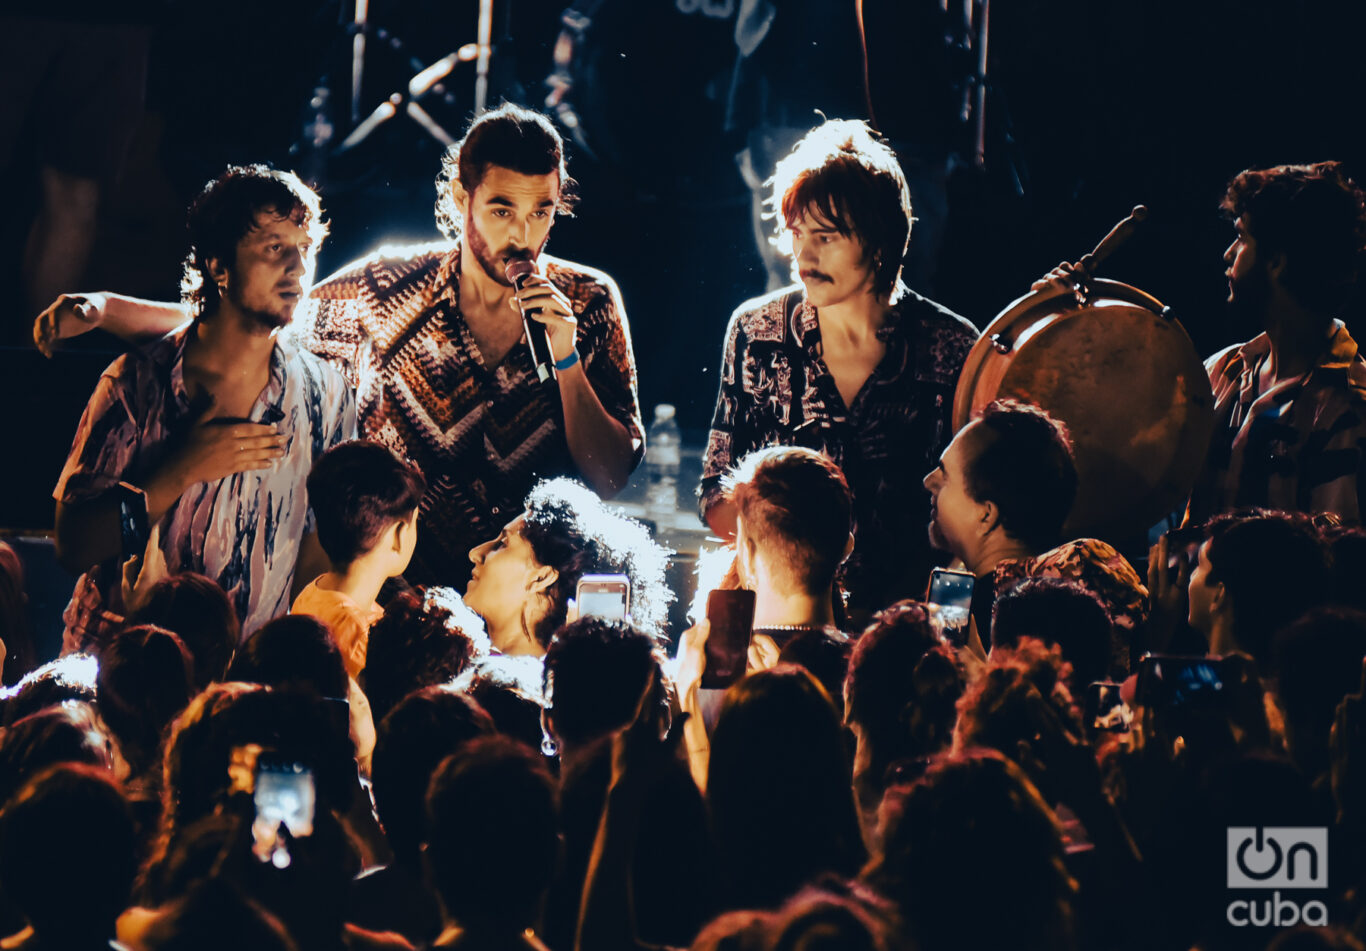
(53, 325, 355, 650)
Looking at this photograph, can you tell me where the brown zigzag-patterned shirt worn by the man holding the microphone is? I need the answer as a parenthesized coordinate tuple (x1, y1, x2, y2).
(298, 243, 645, 589)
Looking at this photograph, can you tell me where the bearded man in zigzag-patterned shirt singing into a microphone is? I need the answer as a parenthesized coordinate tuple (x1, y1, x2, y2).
(36, 105, 645, 588)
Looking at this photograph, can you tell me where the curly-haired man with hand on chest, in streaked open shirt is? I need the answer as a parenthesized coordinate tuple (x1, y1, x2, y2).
(53, 165, 355, 649)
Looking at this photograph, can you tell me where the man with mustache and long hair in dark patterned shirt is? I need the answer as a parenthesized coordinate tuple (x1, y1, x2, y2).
(701, 120, 978, 615)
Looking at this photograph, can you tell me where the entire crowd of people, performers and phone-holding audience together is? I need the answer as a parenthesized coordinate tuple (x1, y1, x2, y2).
(8, 98, 1366, 951)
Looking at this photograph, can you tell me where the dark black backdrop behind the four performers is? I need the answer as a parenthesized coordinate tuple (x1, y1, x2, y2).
(0, 0, 1366, 530)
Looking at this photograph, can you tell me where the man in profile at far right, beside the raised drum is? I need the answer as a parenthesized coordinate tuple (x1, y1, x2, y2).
(1188, 161, 1366, 523)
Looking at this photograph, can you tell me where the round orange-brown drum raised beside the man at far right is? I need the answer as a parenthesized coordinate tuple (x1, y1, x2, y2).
(953, 279, 1214, 544)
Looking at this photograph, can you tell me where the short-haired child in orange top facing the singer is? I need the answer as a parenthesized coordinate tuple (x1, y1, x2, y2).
(290, 440, 426, 679)
